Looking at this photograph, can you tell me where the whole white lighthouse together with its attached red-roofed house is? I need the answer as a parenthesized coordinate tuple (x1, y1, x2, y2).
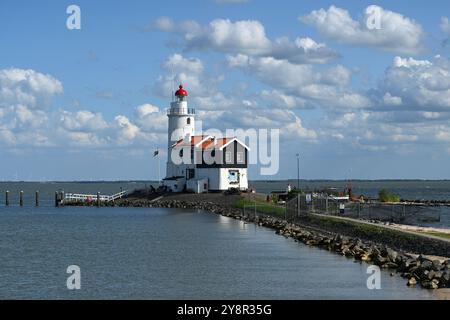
(163, 85, 249, 193)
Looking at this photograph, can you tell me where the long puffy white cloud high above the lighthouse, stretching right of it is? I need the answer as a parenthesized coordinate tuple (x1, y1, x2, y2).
(153, 17, 339, 64)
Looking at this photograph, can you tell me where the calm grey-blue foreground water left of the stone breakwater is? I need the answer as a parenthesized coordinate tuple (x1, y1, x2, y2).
(0, 207, 435, 299)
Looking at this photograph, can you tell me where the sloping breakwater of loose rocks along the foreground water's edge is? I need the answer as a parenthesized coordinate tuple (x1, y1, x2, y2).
(71, 199, 450, 289)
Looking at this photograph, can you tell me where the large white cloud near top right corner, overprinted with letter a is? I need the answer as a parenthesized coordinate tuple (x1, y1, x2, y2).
(299, 5, 424, 54)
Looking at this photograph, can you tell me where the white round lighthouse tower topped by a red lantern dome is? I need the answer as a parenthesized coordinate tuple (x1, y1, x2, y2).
(166, 85, 195, 178)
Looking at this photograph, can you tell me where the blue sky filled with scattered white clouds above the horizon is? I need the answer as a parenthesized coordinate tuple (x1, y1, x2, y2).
(0, 0, 450, 181)
